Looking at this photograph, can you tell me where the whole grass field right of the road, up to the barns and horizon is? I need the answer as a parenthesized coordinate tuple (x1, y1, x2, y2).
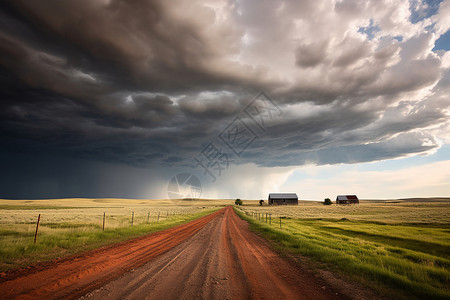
(239, 199, 450, 299)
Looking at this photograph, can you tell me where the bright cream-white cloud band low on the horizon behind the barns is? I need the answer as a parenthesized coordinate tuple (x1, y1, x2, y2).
(282, 160, 450, 200)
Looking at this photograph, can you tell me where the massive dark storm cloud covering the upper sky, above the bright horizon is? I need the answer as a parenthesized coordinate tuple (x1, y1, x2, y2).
(0, 0, 450, 199)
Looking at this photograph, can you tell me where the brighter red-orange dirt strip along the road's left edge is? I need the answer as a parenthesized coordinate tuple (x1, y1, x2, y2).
(0, 209, 225, 299)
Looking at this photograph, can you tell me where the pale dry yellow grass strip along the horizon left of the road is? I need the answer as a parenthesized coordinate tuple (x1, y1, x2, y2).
(0, 198, 233, 228)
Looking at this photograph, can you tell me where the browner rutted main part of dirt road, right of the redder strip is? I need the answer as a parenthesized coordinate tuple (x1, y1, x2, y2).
(85, 207, 344, 299)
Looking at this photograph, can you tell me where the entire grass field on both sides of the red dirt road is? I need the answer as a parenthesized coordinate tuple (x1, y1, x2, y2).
(0, 199, 450, 299)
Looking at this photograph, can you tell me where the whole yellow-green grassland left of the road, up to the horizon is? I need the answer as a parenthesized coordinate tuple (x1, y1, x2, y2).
(0, 199, 227, 271)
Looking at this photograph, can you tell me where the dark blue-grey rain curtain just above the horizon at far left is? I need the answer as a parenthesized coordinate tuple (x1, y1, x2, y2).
(0, 152, 170, 199)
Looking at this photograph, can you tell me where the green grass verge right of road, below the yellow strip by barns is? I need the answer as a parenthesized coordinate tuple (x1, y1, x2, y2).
(235, 209, 450, 299)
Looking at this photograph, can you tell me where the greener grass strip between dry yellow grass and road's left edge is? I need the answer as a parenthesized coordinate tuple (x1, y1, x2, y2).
(0, 208, 220, 272)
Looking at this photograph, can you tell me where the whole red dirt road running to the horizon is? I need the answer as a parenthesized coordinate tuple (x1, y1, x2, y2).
(0, 207, 342, 299)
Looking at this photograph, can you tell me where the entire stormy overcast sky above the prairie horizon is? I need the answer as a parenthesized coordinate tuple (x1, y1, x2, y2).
(0, 0, 450, 200)
